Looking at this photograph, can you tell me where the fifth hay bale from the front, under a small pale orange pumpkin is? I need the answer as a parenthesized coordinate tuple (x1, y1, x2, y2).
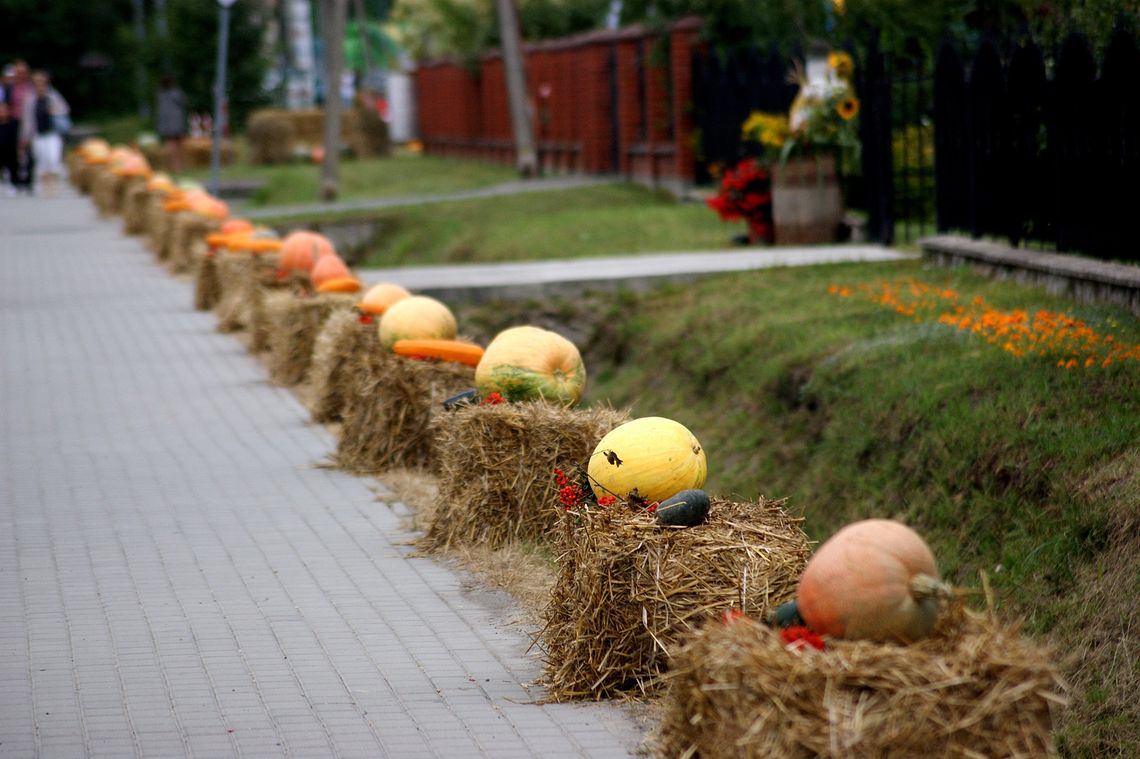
(309, 309, 383, 424)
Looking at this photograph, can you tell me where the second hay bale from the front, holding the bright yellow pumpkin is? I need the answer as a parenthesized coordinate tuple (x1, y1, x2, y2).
(538, 498, 809, 699)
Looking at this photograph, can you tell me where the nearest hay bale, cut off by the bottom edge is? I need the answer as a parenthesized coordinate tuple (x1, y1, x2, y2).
(657, 606, 1064, 759)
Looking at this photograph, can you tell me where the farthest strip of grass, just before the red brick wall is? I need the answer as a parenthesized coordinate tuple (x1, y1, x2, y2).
(187, 154, 516, 206)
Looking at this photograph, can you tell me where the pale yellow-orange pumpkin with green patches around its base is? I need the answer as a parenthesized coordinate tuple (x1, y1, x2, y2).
(475, 327, 586, 406)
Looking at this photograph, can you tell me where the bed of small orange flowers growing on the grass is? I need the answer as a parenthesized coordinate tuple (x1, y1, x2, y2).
(828, 278, 1140, 369)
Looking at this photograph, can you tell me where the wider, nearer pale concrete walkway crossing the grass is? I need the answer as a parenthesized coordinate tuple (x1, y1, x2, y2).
(358, 245, 912, 301)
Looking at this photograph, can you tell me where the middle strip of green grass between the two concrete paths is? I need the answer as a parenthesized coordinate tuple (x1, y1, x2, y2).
(282, 185, 739, 266)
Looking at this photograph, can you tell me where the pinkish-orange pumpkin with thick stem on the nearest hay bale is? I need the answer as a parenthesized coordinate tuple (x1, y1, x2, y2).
(796, 520, 951, 643)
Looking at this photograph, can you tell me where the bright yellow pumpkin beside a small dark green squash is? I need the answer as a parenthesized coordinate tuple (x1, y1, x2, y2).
(588, 414, 708, 501)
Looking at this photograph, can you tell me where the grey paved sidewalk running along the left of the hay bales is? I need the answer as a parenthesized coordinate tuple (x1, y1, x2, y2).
(0, 192, 642, 758)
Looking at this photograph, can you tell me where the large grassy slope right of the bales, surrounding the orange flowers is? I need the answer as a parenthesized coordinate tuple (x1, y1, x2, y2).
(462, 257, 1140, 757)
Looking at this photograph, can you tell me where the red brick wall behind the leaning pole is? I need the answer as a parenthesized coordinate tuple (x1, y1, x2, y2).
(415, 18, 700, 182)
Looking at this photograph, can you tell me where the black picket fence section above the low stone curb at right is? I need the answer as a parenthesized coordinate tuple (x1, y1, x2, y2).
(934, 30, 1140, 260)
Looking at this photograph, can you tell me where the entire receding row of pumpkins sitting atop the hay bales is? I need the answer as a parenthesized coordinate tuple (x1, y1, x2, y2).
(80, 137, 952, 642)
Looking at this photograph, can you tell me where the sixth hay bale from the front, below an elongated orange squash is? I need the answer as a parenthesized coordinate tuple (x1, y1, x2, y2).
(266, 291, 357, 386)
